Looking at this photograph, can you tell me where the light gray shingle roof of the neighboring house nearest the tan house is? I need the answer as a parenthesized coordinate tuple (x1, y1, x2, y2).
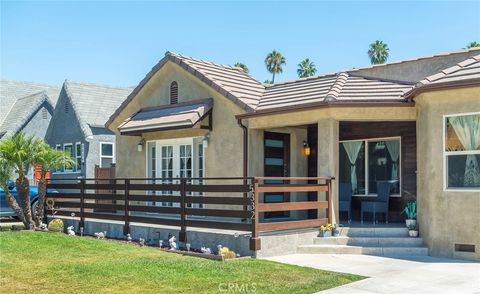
(63, 80, 133, 136)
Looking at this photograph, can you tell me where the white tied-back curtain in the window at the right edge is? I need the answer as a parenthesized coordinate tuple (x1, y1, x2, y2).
(449, 115, 480, 187)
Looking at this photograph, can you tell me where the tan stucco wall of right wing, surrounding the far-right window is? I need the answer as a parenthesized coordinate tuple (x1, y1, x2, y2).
(416, 87, 480, 259)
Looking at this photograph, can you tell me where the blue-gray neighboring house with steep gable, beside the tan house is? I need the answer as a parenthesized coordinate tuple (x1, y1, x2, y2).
(46, 80, 132, 179)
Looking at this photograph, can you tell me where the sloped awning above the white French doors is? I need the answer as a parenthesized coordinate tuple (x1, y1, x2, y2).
(118, 98, 213, 135)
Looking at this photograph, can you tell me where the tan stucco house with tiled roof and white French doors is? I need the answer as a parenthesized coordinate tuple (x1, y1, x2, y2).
(106, 49, 480, 259)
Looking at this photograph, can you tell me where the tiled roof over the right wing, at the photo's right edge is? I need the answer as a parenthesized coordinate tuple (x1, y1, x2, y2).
(417, 55, 480, 87)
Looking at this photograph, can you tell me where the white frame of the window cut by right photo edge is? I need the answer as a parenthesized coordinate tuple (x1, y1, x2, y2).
(442, 112, 480, 192)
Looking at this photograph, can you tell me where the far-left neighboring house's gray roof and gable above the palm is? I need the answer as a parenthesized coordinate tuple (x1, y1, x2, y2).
(0, 80, 60, 139)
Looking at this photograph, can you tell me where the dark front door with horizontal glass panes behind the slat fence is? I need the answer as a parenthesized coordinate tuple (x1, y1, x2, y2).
(263, 132, 290, 219)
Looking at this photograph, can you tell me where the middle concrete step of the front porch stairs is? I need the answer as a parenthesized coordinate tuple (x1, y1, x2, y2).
(313, 236, 423, 247)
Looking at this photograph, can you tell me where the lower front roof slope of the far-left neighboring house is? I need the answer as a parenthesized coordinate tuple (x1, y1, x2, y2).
(0, 91, 53, 136)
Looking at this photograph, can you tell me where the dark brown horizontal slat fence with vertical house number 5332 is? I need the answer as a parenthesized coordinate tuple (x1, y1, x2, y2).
(45, 177, 334, 250)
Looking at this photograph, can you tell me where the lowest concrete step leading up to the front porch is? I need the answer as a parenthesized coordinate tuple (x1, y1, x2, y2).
(297, 245, 428, 256)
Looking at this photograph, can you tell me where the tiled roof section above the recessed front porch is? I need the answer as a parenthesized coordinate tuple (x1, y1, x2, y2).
(255, 72, 413, 111)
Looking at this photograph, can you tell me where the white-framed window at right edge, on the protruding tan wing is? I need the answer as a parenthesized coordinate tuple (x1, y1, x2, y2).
(443, 113, 480, 191)
